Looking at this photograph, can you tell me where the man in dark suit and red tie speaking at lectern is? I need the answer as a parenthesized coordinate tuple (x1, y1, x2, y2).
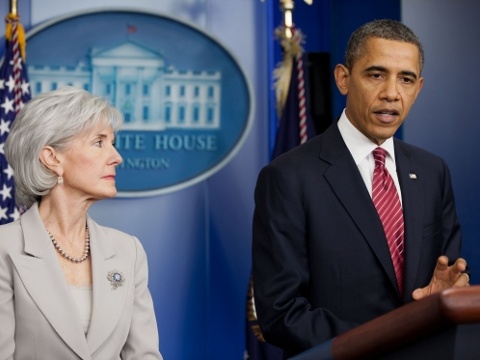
(253, 20, 469, 357)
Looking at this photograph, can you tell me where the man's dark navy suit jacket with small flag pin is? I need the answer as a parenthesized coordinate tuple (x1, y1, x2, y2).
(253, 124, 461, 356)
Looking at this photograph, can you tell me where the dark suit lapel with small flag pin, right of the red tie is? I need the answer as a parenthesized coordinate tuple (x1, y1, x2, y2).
(395, 141, 424, 299)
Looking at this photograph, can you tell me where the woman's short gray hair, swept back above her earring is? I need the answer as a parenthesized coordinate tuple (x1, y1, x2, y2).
(5, 86, 123, 208)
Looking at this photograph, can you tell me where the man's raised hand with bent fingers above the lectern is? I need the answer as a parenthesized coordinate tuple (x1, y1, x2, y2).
(412, 256, 470, 300)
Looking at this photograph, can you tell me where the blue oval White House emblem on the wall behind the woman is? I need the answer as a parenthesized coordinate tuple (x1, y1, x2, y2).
(27, 10, 253, 197)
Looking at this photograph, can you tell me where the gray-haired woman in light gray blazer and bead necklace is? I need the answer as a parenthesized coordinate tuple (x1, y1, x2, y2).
(0, 87, 162, 360)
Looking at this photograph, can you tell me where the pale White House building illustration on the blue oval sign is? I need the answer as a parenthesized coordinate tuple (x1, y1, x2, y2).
(28, 40, 221, 131)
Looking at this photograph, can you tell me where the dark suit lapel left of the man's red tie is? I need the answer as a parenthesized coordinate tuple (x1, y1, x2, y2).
(320, 124, 398, 291)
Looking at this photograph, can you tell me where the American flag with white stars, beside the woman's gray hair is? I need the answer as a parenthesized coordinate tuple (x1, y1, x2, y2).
(0, 14, 31, 225)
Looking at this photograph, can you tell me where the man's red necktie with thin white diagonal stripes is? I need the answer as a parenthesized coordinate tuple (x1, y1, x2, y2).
(372, 147, 404, 294)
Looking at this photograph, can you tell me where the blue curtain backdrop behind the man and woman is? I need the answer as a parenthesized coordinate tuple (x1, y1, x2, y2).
(0, 0, 480, 360)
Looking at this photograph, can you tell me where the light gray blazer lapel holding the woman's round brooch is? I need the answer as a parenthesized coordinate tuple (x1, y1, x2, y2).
(87, 218, 134, 354)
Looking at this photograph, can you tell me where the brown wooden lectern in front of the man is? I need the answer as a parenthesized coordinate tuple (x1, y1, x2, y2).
(290, 286, 480, 360)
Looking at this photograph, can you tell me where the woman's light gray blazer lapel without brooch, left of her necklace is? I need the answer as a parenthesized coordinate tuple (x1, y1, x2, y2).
(12, 204, 91, 359)
